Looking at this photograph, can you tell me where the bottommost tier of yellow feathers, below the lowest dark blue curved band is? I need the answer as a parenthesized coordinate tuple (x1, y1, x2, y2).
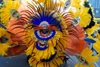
(29, 52, 64, 67)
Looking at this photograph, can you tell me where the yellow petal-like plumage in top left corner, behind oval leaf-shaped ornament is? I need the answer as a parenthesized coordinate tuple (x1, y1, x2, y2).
(0, 0, 21, 26)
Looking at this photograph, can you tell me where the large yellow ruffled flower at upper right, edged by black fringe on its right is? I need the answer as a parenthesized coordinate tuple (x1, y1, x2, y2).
(74, 6, 91, 27)
